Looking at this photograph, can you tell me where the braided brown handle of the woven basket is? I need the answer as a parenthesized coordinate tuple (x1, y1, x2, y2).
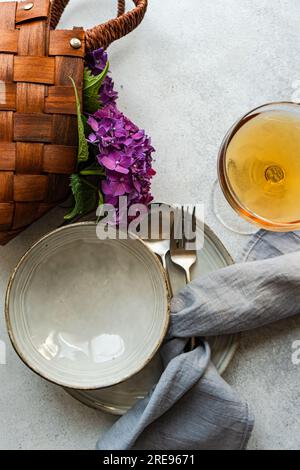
(51, 0, 148, 52)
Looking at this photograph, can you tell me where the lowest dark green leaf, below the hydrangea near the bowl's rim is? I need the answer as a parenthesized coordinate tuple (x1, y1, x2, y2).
(64, 174, 98, 220)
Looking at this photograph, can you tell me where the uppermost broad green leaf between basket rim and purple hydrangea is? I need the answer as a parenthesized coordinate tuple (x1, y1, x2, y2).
(83, 61, 109, 114)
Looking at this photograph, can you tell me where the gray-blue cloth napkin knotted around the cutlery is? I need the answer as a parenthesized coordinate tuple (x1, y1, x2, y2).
(97, 231, 300, 450)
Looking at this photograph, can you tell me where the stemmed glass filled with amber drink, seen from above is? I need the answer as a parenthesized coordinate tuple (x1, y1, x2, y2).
(218, 102, 300, 233)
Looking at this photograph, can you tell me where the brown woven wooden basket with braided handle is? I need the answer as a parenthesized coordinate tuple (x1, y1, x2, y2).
(0, 0, 147, 245)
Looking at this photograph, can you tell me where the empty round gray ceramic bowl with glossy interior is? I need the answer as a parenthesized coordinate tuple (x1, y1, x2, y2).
(6, 222, 169, 390)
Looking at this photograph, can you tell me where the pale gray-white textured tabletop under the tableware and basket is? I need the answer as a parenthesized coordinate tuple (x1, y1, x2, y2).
(0, 0, 300, 449)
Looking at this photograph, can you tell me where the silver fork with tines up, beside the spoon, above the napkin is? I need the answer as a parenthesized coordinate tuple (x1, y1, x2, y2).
(170, 206, 197, 283)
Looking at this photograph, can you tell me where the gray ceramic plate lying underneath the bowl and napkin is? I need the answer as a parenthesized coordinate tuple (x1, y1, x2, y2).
(66, 220, 238, 415)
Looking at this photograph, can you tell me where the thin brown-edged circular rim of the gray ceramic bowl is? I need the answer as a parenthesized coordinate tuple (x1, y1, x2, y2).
(4, 221, 171, 391)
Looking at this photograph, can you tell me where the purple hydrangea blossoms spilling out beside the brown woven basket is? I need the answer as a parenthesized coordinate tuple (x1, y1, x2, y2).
(86, 49, 155, 211)
